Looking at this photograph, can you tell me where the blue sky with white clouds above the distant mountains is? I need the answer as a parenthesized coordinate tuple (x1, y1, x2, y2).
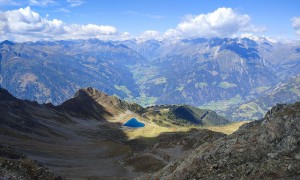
(0, 0, 300, 42)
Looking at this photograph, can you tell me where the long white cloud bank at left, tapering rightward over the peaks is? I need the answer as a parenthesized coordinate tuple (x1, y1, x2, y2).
(0, 7, 129, 42)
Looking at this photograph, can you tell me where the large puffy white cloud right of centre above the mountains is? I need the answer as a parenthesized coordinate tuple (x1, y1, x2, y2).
(164, 8, 266, 38)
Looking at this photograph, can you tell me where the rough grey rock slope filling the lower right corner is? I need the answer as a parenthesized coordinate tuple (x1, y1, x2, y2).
(142, 102, 300, 179)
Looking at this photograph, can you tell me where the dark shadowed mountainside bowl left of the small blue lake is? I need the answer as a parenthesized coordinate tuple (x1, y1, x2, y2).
(0, 90, 131, 178)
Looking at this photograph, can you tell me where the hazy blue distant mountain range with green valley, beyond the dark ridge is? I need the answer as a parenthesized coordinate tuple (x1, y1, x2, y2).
(0, 38, 300, 120)
